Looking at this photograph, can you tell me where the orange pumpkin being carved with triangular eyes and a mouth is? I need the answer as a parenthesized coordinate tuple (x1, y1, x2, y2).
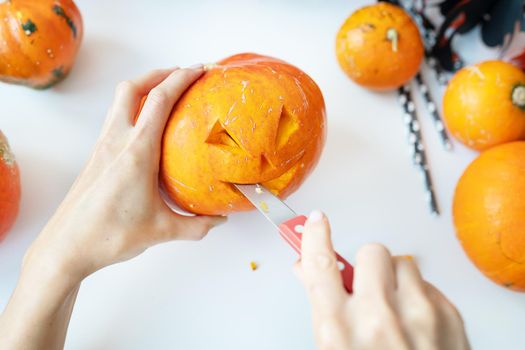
(161, 54, 326, 215)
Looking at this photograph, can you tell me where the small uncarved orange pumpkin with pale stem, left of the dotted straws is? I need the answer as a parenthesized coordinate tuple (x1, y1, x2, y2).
(336, 2, 424, 90)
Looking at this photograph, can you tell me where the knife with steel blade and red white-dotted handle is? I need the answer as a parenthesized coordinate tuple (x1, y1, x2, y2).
(235, 184, 354, 293)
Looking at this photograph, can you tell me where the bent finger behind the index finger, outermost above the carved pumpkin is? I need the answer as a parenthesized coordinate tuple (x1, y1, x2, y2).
(103, 68, 177, 132)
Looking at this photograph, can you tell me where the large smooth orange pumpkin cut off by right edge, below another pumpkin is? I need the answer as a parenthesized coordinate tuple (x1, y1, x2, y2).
(453, 141, 525, 291)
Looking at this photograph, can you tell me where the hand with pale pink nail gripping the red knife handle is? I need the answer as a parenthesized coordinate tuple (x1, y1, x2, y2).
(295, 212, 469, 350)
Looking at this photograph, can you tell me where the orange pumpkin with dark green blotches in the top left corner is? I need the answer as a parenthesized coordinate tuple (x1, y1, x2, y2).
(0, 0, 82, 89)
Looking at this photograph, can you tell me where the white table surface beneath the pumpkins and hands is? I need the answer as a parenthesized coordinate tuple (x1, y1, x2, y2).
(0, 0, 525, 350)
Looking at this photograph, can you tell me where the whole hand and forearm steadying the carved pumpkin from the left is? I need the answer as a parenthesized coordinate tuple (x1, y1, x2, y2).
(0, 67, 225, 349)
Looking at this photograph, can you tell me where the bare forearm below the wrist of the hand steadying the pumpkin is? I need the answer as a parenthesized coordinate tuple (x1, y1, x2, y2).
(0, 246, 80, 350)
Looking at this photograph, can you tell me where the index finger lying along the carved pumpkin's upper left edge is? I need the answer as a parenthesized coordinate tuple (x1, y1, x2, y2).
(135, 65, 204, 140)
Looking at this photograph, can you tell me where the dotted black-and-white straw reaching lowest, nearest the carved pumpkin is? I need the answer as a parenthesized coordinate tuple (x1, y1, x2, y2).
(397, 84, 439, 215)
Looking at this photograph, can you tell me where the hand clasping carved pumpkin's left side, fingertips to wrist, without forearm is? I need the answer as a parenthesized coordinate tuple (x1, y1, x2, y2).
(25, 67, 225, 284)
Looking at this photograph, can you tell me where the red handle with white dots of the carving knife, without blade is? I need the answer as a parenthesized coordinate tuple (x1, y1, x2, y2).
(279, 215, 354, 293)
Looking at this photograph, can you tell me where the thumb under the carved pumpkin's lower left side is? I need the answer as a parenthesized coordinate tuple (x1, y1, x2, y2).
(153, 208, 228, 243)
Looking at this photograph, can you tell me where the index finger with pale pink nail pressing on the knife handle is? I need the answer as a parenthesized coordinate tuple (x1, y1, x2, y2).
(301, 211, 347, 313)
